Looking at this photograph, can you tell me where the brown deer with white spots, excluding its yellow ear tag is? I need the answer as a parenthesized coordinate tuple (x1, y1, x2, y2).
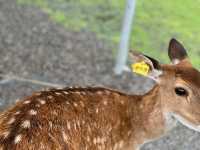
(0, 38, 200, 150)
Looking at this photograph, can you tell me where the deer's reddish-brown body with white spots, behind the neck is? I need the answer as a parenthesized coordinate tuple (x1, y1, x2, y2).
(0, 88, 139, 150)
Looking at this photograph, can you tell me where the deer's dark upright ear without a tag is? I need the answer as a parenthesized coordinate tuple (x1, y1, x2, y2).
(168, 39, 191, 65)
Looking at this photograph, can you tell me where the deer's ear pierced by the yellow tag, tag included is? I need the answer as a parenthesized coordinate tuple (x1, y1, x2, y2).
(129, 51, 162, 81)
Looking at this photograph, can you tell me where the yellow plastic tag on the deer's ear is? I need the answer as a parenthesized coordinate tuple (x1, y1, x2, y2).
(131, 61, 150, 76)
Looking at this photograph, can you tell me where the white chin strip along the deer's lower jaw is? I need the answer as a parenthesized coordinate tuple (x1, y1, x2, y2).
(171, 113, 200, 132)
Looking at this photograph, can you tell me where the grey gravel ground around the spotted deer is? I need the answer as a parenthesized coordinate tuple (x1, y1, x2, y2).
(0, 0, 200, 150)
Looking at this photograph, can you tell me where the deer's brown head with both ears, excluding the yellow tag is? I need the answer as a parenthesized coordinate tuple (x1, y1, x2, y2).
(132, 39, 200, 132)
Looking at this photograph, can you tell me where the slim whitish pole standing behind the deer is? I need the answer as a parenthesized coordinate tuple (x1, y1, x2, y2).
(114, 0, 136, 75)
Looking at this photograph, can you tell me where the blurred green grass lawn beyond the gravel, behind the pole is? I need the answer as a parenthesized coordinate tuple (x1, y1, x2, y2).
(17, 0, 200, 68)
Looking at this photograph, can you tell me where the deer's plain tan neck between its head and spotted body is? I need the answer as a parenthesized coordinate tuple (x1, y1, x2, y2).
(134, 85, 165, 147)
